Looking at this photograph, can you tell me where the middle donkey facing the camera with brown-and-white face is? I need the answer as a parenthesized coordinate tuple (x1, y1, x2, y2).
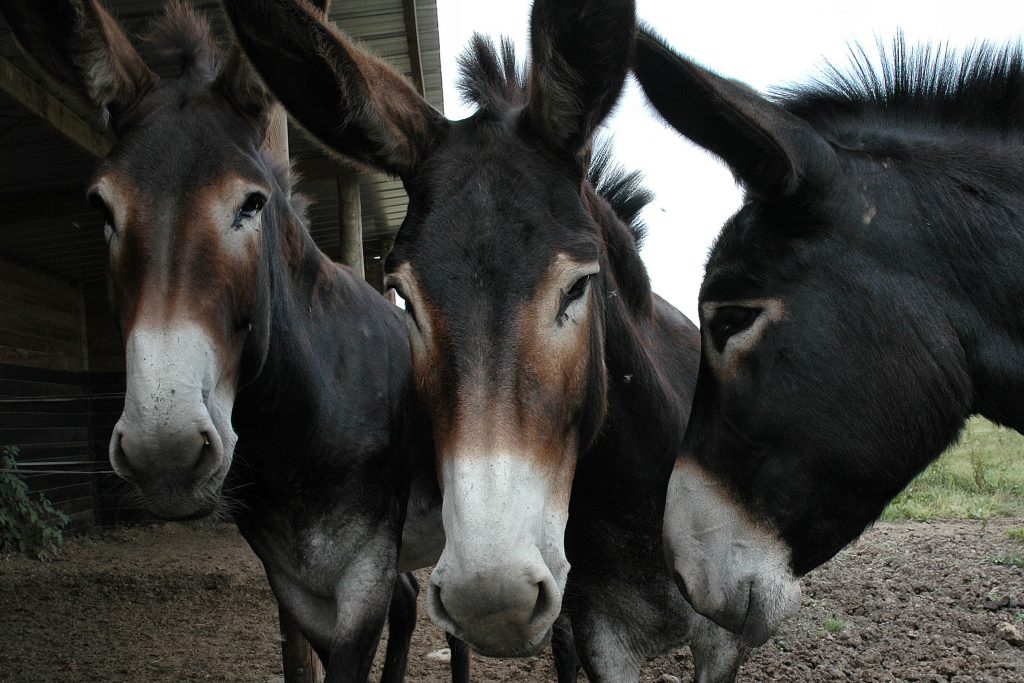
(224, 0, 745, 681)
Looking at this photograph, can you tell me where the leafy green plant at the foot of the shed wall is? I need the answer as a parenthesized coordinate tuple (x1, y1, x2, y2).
(0, 445, 68, 560)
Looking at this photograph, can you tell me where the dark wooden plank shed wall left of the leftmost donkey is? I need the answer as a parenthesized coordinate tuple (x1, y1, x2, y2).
(0, 260, 124, 530)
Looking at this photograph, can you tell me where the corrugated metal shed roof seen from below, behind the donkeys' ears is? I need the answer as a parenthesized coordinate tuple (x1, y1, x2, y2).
(0, 0, 443, 282)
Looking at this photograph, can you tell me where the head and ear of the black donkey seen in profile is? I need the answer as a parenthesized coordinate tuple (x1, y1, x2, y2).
(634, 32, 978, 643)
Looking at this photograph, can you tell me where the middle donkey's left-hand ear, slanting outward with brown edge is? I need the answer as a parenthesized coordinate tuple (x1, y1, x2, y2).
(224, 0, 447, 178)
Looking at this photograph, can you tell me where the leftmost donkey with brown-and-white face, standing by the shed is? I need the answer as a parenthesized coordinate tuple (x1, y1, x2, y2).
(0, 0, 452, 681)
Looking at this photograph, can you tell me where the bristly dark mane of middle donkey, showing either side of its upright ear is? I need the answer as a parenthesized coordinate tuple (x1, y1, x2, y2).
(459, 34, 654, 249)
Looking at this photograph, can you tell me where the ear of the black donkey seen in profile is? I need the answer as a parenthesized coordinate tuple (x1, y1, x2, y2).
(633, 27, 838, 197)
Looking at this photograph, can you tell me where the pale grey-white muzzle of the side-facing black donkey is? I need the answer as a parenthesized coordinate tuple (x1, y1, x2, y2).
(663, 460, 801, 646)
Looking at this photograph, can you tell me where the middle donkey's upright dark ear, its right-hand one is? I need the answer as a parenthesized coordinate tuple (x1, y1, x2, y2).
(527, 0, 636, 166)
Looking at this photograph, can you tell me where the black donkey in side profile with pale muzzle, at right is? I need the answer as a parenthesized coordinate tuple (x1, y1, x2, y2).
(634, 31, 1024, 643)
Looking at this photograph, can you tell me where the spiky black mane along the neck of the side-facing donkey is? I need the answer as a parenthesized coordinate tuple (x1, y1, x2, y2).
(776, 34, 1024, 138)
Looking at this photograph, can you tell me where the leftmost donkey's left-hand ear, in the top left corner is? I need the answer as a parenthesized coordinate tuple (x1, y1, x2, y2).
(0, 0, 156, 124)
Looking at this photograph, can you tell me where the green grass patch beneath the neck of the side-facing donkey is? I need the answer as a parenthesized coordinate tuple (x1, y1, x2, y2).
(882, 418, 1024, 524)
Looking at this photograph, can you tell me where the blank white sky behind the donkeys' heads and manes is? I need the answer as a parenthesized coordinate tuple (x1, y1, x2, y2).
(437, 0, 1024, 322)
